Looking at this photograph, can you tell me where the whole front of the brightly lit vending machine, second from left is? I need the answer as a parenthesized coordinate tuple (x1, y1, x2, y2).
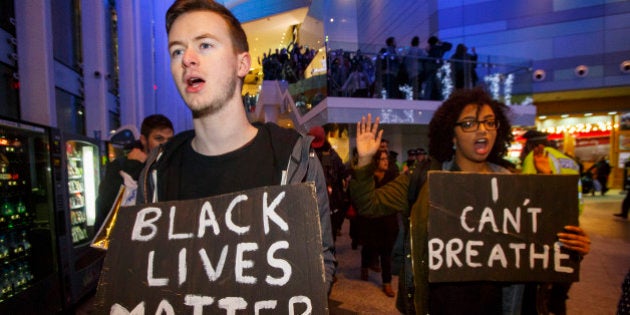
(51, 134, 104, 308)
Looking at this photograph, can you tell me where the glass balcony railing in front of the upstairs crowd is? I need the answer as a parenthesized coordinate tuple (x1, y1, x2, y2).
(246, 43, 532, 114)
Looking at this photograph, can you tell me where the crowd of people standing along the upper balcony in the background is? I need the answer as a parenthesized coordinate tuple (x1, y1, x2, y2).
(259, 36, 479, 100)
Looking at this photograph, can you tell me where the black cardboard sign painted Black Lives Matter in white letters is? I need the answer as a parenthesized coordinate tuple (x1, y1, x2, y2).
(95, 184, 328, 314)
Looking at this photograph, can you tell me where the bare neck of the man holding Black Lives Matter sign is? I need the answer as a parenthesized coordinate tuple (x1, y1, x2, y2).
(192, 104, 258, 156)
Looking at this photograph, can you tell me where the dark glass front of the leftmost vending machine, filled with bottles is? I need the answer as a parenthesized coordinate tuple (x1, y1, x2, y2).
(0, 119, 61, 314)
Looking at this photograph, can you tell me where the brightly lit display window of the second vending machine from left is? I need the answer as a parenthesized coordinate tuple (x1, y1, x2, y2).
(66, 140, 99, 245)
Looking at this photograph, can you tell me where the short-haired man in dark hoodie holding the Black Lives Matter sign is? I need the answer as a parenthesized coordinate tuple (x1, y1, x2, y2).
(137, 0, 335, 292)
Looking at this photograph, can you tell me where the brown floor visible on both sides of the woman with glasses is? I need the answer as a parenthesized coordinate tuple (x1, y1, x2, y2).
(330, 190, 630, 315)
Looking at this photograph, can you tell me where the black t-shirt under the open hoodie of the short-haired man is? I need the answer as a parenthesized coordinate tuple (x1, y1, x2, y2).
(177, 128, 282, 200)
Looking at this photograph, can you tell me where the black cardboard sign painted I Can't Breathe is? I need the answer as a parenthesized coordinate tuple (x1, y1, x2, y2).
(427, 172, 579, 282)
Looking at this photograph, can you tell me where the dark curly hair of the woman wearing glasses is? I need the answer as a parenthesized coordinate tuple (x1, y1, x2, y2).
(429, 88, 513, 165)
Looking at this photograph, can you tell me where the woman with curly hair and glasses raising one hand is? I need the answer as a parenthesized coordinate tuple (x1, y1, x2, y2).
(350, 88, 590, 314)
